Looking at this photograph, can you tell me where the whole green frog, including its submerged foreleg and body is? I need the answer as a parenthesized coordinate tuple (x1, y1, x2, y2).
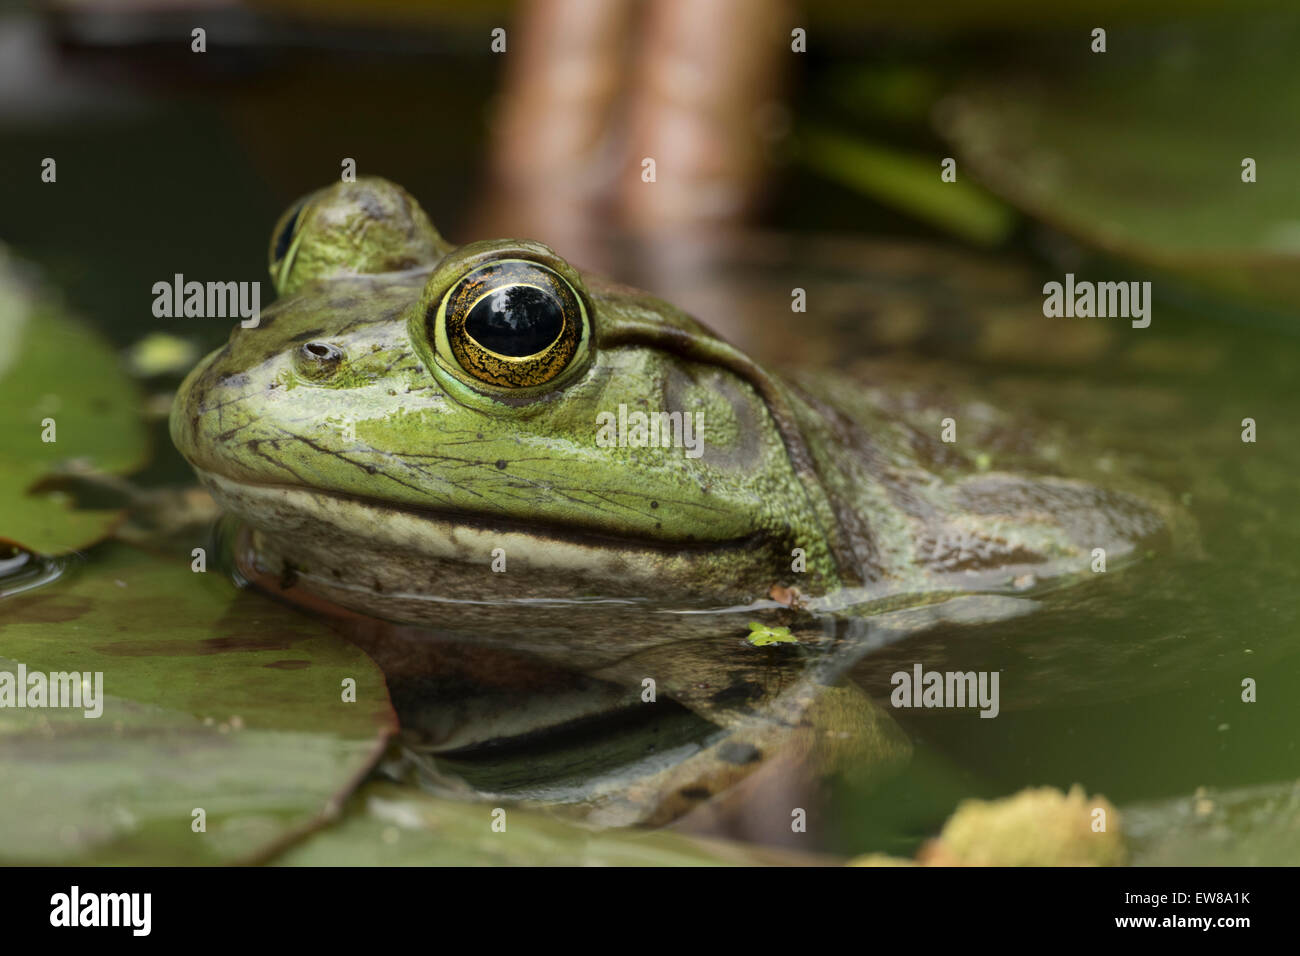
(172, 178, 1167, 822)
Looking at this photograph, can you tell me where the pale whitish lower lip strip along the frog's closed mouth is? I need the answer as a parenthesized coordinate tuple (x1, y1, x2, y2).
(191, 463, 762, 557)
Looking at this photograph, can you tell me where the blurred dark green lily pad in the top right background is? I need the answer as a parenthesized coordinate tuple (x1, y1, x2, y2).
(936, 18, 1300, 310)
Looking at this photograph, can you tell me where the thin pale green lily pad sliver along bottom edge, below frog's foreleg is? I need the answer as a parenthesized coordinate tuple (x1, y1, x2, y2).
(274, 783, 833, 866)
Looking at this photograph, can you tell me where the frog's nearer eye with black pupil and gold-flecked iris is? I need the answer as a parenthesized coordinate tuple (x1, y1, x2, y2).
(430, 259, 586, 388)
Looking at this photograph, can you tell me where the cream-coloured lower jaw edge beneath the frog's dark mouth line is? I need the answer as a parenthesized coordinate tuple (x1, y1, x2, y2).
(195, 467, 763, 564)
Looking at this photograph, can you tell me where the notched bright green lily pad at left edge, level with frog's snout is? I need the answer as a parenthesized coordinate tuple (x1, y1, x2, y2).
(0, 248, 146, 554)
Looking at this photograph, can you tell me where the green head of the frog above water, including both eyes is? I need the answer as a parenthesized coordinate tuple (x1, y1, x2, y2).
(170, 178, 837, 610)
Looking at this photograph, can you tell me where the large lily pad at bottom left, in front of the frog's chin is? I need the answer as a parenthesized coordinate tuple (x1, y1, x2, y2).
(0, 545, 395, 865)
